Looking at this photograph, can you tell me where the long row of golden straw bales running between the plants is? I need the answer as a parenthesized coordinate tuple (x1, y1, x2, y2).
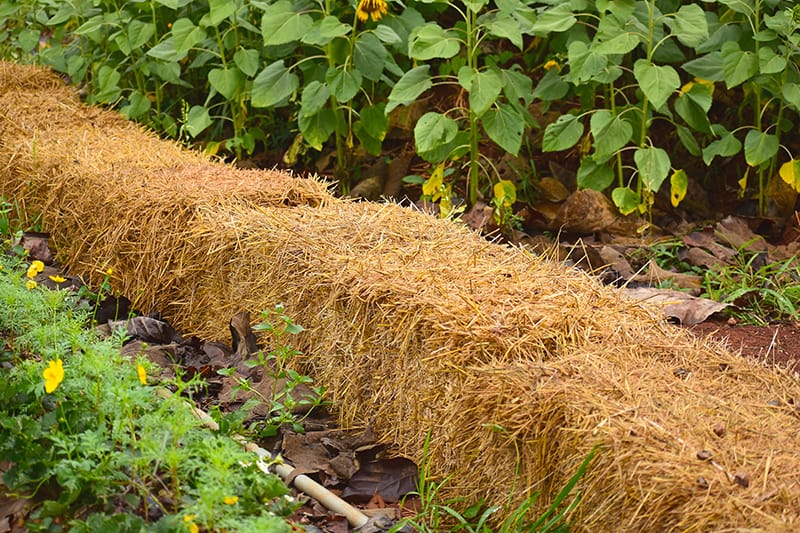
(0, 63, 800, 531)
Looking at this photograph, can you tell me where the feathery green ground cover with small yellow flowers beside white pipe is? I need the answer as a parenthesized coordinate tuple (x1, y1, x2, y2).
(0, 252, 296, 532)
